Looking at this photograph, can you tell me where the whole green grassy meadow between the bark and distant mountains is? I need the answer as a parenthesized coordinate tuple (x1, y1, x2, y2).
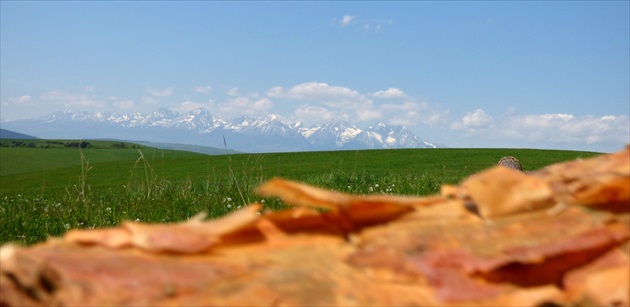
(0, 140, 597, 244)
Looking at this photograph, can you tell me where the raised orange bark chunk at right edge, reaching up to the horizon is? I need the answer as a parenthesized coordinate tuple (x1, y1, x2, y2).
(450, 146, 630, 218)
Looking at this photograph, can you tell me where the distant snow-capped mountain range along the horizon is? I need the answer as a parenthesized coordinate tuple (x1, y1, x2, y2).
(2, 108, 436, 152)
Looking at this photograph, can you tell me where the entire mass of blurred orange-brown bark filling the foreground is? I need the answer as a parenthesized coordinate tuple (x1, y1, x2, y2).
(0, 147, 630, 306)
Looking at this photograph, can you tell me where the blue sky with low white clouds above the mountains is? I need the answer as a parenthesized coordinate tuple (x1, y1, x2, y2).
(0, 1, 630, 151)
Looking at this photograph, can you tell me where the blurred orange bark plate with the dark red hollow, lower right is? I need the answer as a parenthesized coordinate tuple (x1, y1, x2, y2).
(347, 208, 630, 304)
